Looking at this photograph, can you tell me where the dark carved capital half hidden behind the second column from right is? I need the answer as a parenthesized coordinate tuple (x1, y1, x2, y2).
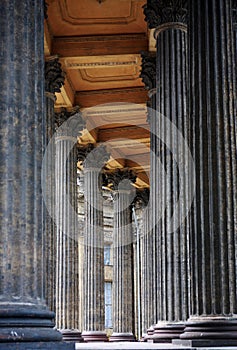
(140, 51, 156, 90)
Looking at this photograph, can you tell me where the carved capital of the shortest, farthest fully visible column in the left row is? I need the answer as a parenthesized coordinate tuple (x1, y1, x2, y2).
(106, 168, 137, 191)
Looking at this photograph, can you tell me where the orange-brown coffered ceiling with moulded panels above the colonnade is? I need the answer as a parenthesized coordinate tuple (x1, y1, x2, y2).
(45, 0, 153, 187)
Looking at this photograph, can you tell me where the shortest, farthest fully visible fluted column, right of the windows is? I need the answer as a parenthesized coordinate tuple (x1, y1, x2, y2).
(108, 169, 136, 341)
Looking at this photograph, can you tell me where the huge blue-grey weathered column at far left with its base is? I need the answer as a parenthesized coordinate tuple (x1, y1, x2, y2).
(0, 0, 72, 350)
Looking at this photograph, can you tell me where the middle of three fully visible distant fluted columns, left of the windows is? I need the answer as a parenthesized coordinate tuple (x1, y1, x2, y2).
(79, 145, 109, 342)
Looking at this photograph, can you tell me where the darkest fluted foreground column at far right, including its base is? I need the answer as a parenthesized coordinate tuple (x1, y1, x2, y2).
(176, 0, 237, 347)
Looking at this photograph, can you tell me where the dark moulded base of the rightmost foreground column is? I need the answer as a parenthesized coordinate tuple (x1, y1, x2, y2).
(177, 317, 237, 347)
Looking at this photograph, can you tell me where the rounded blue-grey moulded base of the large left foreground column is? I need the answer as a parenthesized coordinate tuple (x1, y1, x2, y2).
(0, 303, 62, 343)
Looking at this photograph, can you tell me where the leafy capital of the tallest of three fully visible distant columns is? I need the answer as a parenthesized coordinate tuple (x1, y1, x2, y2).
(55, 106, 86, 138)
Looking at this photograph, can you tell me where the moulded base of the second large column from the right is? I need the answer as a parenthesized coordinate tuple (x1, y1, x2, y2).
(150, 322, 185, 343)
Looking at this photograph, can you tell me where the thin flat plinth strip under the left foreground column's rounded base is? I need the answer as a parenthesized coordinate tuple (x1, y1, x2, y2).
(0, 342, 75, 350)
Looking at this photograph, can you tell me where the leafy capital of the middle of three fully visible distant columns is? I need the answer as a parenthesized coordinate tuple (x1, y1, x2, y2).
(78, 144, 110, 171)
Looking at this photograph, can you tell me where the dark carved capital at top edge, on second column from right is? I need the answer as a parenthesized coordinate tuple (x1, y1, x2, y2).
(144, 0, 187, 29)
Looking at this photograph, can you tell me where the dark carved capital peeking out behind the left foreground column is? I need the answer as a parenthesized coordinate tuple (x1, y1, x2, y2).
(45, 57, 65, 94)
